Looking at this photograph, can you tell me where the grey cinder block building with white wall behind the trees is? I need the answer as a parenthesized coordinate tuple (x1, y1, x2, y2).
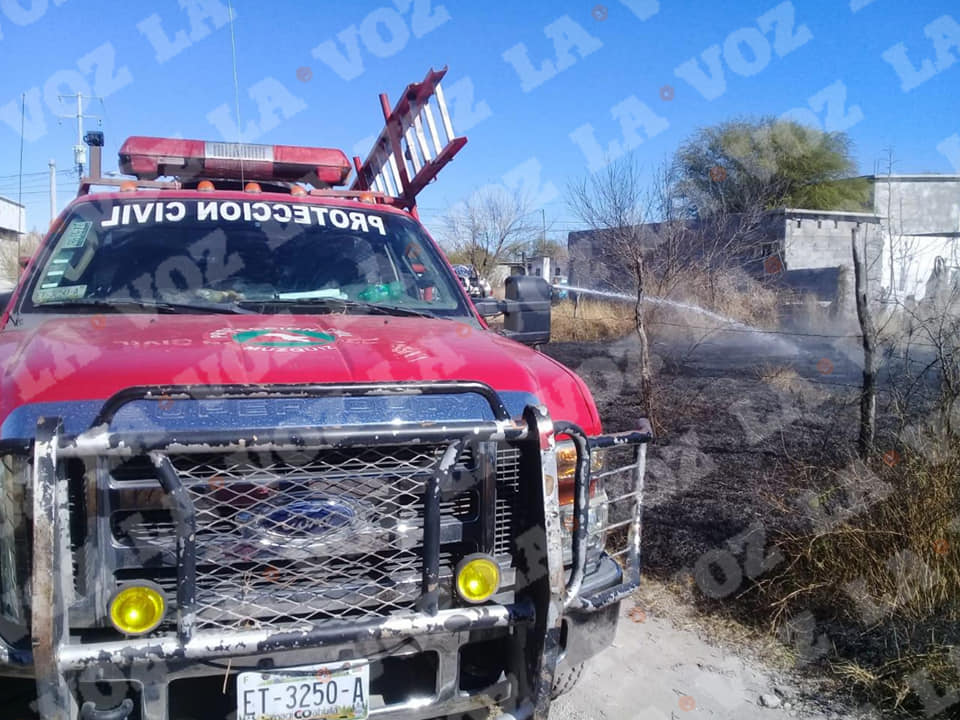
(567, 175, 960, 310)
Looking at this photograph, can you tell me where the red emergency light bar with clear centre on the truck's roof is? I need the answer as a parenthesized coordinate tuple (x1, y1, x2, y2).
(120, 137, 350, 187)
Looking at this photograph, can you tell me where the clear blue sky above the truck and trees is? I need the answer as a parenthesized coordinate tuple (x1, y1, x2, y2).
(0, 0, 960, 237)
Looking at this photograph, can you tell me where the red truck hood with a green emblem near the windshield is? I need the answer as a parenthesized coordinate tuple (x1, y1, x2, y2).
(0, 314, 600, 438)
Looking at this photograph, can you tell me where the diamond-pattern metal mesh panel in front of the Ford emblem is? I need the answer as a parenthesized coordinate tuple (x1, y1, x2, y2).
(174, 446, 441, 627)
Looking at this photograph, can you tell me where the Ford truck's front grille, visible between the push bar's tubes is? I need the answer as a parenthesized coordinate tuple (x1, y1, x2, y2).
(98, 445, 519, 629)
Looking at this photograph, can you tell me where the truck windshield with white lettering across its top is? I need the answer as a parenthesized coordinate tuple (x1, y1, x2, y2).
(20, 199, 469, 317)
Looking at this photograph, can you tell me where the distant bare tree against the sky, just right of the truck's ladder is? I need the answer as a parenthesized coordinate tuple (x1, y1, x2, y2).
(441, 186, 538, 277)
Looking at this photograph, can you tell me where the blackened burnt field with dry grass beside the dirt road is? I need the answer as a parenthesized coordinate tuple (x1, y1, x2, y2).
(545, 325, 960, 717)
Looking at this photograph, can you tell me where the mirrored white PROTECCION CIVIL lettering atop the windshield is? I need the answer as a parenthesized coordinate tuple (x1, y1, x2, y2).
(100, 200, 387, 235)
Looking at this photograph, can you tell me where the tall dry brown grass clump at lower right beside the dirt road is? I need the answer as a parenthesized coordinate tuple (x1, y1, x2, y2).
(757, 447, 960, 716)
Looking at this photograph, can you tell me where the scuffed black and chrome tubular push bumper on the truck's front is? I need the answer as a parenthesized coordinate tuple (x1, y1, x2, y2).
(0, 382, 652, 720)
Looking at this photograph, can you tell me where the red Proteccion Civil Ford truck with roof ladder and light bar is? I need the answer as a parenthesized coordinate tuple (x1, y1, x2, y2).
(0, 70, 651, 720)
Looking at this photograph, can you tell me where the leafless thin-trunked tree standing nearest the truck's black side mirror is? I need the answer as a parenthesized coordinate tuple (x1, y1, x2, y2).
(567, 155, 654, 420)
